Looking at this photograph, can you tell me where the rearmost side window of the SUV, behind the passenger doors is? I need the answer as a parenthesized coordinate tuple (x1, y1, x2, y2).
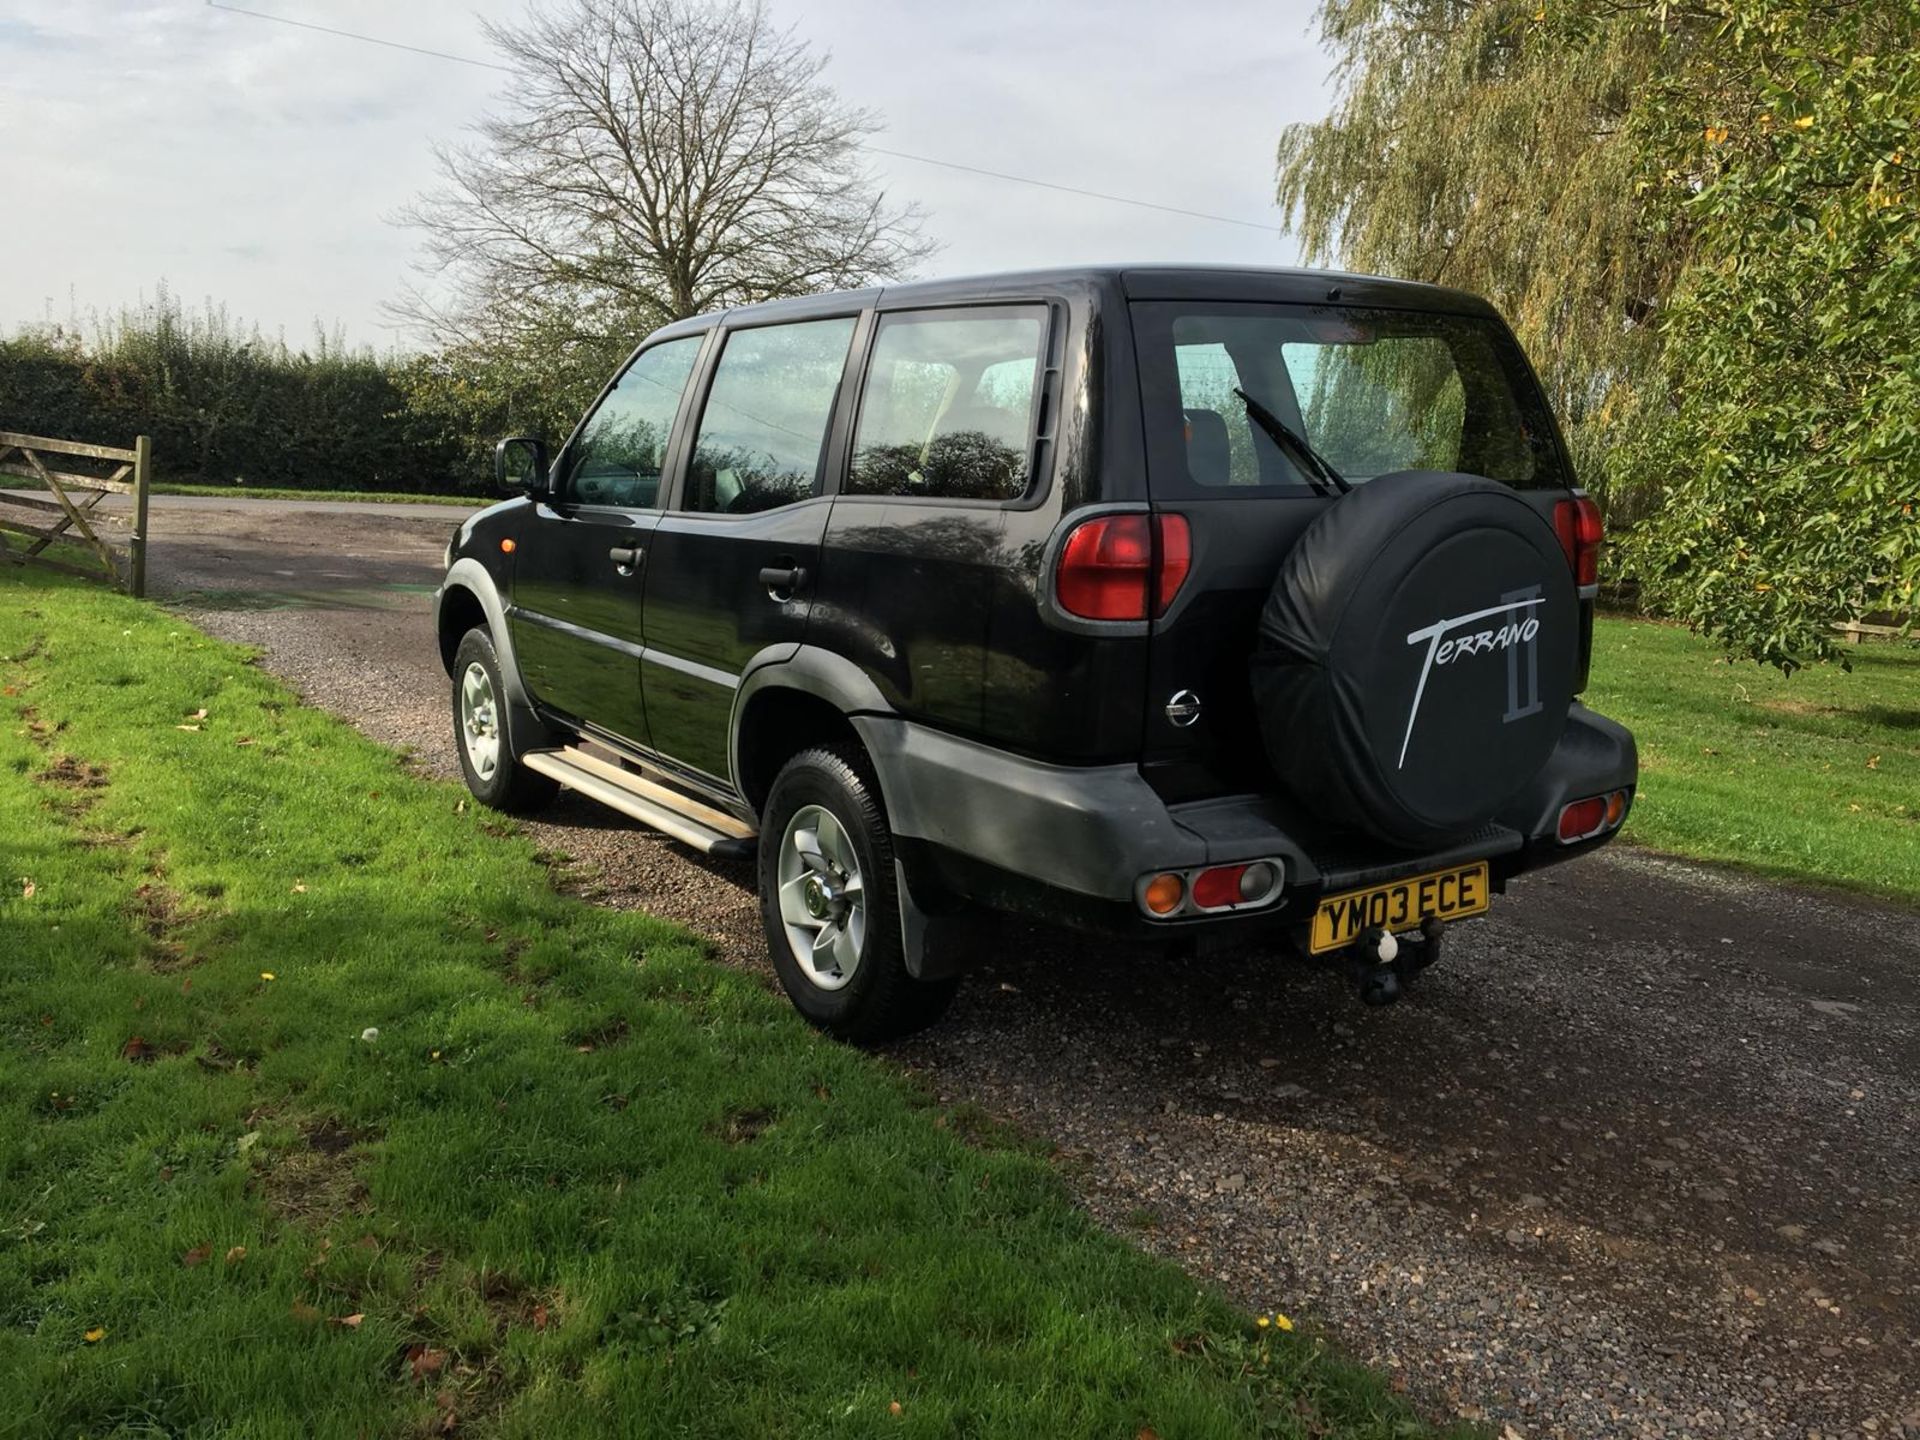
(847, 307, 1046, 499)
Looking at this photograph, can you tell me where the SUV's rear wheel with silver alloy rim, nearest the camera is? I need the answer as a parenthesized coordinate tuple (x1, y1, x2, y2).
(760, 745, 960, 1044)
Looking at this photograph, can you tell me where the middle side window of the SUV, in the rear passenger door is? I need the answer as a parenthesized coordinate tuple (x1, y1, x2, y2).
(685, 315, 854, 515)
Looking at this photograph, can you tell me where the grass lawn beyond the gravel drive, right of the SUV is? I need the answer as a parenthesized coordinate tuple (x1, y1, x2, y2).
(1586, 620, 1920, 900)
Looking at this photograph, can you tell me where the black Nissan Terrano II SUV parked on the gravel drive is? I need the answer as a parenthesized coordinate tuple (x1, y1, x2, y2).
(436, 267, 1636, 1041)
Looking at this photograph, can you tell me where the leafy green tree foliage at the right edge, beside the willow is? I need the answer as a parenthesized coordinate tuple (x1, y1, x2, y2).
(1626, 0, 1920, 668)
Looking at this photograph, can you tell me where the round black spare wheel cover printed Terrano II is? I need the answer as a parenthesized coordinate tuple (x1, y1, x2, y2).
(1252, 470, 1580, 847)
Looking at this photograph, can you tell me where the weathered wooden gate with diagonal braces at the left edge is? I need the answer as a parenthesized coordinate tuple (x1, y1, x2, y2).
(0, 430, 154, 597)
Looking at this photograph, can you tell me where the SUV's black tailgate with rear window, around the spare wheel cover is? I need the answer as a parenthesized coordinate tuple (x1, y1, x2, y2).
(1131, 300, 1567, 799)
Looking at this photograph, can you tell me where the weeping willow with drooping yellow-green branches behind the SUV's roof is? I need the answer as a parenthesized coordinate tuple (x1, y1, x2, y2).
(1279, 0, 1684, 520)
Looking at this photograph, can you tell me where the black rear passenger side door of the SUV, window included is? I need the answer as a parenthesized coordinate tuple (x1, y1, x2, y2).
(641, 313, 860, 787)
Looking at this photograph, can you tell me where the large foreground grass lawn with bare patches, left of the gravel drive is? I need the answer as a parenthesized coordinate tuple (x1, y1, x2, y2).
(0, 570, 1466, 1440)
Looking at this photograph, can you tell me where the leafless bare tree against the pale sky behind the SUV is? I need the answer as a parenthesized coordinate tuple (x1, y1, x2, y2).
(392, 0, 933, 353)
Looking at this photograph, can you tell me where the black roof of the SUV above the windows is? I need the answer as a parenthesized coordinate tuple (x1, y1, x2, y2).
(659, 265, 1494, 334)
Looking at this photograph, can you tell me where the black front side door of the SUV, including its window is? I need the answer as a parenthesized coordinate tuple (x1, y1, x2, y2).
(507, 334, 705, 745)
